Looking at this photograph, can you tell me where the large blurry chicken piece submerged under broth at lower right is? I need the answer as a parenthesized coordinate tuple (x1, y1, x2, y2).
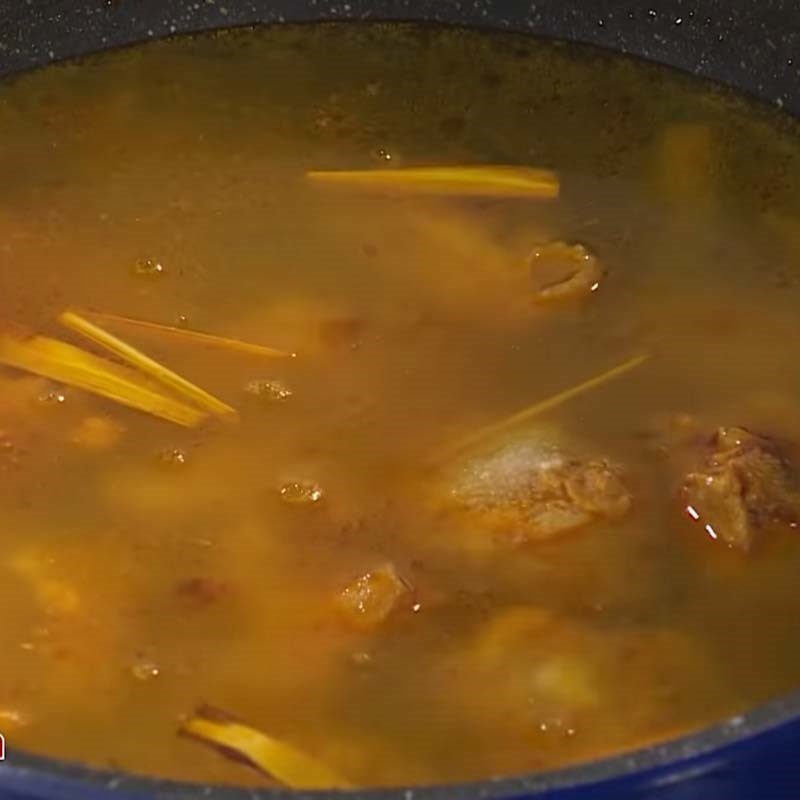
(432, 606, 719, 766)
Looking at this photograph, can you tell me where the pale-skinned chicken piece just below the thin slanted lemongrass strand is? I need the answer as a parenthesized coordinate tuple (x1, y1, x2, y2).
(450, 439, 631, 541)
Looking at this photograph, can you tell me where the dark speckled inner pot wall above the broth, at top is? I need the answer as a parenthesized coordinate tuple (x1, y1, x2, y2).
(0, 0, 800, 114)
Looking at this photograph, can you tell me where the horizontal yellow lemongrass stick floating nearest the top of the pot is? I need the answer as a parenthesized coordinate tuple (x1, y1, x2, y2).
(306, 165, 559, 198)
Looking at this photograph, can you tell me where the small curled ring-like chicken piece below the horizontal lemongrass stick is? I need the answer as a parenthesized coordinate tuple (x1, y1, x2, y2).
(530, 242, 603, 303)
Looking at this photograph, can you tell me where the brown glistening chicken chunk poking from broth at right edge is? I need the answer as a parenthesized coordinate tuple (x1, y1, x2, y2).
(681, 427, 800, 552)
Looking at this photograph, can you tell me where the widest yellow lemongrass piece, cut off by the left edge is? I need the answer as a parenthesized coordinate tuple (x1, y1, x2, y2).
(0, 331, 208, 428)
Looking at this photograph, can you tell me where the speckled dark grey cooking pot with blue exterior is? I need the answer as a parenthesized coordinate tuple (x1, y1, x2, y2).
(0, 0, 800, 800)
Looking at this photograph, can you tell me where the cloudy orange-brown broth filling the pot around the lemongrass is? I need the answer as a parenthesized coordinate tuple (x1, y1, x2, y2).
(0, 24, 800, 786)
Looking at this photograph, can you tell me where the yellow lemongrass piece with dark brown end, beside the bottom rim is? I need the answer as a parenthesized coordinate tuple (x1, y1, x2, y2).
(181, 709, 352, 789)
